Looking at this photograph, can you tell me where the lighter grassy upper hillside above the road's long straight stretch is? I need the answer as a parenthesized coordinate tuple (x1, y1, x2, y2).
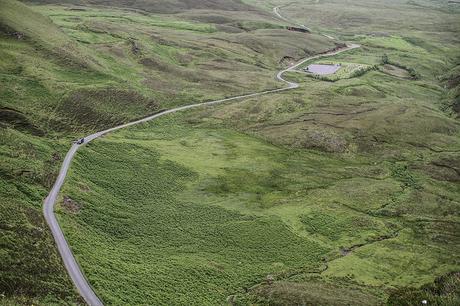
(2, 1, 333, 132)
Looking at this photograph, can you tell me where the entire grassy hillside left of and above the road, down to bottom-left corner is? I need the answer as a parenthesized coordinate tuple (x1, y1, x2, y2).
(0, 0, 332, 304)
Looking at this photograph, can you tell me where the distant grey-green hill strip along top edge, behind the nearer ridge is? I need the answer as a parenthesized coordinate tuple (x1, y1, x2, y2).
(21, 0, 253, 13)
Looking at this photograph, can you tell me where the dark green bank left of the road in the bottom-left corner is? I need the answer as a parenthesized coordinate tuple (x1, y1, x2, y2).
(0, 129, 79, 305)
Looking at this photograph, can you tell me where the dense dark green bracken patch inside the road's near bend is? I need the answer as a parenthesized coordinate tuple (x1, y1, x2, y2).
(60, 122, 334, 305)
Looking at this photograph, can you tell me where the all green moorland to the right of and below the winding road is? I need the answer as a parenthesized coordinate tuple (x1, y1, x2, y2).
(54, 2, 460, 305)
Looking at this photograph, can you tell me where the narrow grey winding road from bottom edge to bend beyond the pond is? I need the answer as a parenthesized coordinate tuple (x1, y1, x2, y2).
(43, 40, 359, 306)
